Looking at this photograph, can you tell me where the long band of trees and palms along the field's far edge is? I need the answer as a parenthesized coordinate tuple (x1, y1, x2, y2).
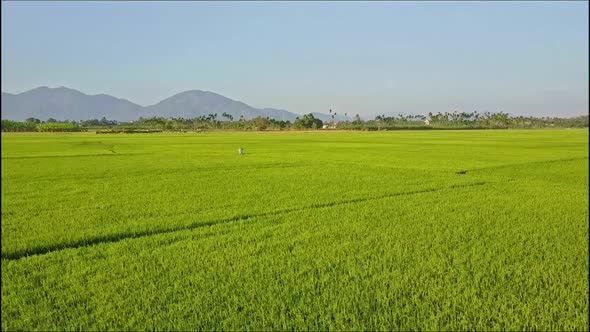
(2, 112, 588, 133)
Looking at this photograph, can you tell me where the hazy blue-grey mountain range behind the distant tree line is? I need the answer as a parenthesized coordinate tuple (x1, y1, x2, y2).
(1, 86, 352, 121)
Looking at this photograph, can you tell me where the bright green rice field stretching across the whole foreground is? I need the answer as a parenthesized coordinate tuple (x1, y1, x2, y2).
(1, 130, 589, 330)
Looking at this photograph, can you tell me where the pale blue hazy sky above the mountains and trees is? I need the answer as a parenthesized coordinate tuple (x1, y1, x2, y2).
(2, 1, 588, 116)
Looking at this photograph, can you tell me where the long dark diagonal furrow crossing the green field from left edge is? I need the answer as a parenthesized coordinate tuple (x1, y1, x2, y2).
(1, 181, 486, 260)
